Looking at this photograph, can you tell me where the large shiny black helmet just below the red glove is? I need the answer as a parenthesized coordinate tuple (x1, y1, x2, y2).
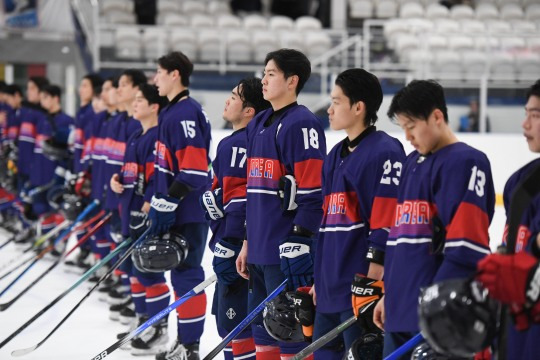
(418, 279, 499, 357)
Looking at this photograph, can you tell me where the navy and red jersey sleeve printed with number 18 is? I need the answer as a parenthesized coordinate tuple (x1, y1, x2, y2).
(278, 119, 326, 233)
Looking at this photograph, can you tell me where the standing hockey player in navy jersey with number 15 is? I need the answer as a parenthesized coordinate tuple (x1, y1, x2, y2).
(148, 52, 211, 360)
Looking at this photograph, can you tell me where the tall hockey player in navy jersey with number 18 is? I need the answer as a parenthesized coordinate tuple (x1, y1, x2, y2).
(236, 49, 326, 360)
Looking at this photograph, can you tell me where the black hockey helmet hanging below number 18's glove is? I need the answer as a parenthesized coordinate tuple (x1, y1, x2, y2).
(263, 292, 304, 342)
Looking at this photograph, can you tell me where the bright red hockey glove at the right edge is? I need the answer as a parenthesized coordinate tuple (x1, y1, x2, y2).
(477, 252, 540, 306)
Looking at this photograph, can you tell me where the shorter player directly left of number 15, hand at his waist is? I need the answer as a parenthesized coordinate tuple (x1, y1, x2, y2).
(110, 84, 170, 355)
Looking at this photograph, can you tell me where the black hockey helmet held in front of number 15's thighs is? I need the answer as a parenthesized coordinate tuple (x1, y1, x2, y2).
(131, 232, 189, 273)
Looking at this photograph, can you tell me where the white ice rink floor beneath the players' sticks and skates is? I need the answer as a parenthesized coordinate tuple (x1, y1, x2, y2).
(0, 206, 504, 360)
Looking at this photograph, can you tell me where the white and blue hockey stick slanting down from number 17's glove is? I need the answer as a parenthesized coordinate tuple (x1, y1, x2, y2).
(88, 274, 217, 360)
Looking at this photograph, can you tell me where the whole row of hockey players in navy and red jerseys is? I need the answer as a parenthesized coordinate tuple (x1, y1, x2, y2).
(0, 49, 540, 360)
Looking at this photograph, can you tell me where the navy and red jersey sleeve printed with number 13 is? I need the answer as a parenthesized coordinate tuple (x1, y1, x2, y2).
(432, 154, 495, 282)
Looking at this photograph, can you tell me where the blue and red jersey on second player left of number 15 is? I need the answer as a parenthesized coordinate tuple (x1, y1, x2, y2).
(102, 112, 141, 210)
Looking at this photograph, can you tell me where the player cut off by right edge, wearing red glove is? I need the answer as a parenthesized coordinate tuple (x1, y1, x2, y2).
(478, 80, 540, 359)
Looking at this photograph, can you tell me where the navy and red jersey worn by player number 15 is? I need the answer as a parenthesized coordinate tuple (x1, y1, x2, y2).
(154, 96, 212, 225)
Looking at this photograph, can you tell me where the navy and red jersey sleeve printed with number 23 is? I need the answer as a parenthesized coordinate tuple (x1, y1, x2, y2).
(361, 145, 405, 251)
